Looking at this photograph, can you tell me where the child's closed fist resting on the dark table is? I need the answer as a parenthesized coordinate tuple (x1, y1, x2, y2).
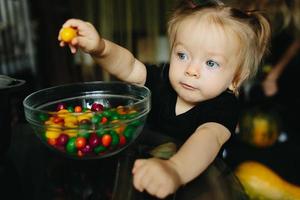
(132, 158, 182, 198)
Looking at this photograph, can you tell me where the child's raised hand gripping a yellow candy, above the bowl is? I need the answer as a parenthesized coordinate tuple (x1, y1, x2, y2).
(58, 19, 104, 55)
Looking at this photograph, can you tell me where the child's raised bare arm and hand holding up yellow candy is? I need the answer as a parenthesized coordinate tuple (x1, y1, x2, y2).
(58, 19, 146, 85)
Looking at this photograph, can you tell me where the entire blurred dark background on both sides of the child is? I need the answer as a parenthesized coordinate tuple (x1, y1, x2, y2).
(0, 0, 300, 198)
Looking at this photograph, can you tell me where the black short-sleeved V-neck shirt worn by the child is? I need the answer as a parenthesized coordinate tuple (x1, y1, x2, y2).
(145, 64, 239, 142)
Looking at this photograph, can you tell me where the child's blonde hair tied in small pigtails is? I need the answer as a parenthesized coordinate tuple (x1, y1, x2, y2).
(168, 3, 271, 88)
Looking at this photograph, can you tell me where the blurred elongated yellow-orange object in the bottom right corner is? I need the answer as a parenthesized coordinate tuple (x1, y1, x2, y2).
(235, 161, 300, 200)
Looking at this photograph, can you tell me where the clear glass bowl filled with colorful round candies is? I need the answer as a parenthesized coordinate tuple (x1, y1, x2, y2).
(23, 82, 150, 159)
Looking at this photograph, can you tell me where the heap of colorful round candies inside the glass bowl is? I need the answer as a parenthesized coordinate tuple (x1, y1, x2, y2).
(39, 102, 142, 157)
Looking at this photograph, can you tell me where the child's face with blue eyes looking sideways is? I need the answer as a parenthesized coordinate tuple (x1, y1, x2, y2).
(169, 18, 238, 104)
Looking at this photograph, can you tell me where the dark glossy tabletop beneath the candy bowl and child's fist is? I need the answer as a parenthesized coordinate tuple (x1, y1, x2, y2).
(0, 123, 247, 200)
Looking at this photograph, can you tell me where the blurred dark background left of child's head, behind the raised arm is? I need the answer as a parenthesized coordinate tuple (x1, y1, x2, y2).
(0, 0, 174, 87)
